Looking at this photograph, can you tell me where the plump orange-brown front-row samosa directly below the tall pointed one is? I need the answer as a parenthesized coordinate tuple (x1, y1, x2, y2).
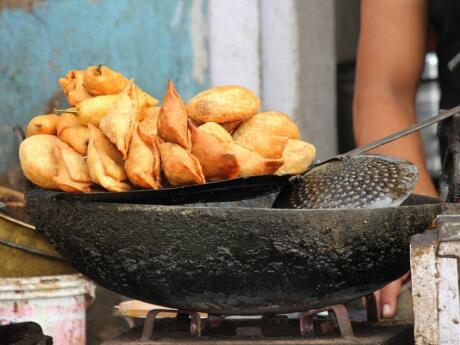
(158, 141, 205, 186)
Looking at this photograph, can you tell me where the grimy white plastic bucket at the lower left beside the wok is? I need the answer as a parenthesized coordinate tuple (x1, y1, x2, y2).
(0, 274, 95, 345)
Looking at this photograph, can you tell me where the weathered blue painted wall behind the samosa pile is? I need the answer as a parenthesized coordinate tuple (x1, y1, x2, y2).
(0, 0, 209, 174)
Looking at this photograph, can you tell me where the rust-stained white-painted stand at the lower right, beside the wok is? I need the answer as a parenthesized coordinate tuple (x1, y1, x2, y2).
(411, 204, 460, 345)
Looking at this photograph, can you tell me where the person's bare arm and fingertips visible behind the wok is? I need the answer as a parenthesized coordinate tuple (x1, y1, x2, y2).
(353, 0, 437, 318)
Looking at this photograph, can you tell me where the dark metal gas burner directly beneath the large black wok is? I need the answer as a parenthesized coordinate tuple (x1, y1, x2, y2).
(103, 298, 413, 345)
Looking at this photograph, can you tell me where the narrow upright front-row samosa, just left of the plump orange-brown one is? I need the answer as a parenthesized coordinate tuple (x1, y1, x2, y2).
(125, 126, 161, 189)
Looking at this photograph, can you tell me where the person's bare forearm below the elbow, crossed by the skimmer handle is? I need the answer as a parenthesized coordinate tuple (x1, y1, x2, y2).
(354, 90, 437, 196)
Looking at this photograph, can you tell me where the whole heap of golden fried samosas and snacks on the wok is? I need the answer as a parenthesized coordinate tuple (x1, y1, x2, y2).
(19, 65, 315, 192)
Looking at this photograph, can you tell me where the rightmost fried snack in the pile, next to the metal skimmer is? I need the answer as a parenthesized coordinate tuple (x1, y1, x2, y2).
(276, 139, 316, 175)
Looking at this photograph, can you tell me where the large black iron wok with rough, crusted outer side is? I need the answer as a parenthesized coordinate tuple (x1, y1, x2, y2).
(27, 189, 441, 314)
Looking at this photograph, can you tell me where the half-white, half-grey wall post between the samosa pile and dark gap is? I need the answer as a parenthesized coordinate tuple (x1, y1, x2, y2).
(260, 0, 337, 160)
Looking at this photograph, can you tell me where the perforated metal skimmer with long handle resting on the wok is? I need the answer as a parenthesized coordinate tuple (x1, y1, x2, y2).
(282, 106, 460, 209)
